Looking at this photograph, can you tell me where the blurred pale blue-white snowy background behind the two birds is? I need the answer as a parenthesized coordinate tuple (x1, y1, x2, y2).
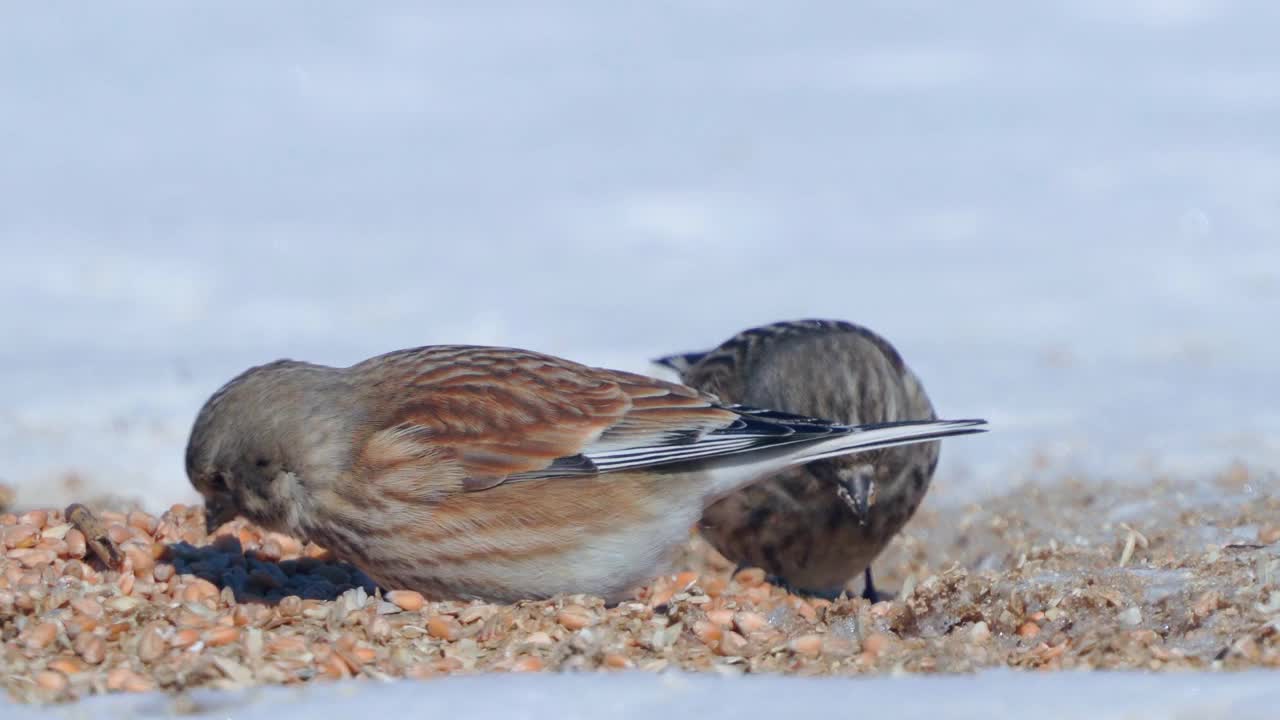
(0, 0, 1280, 509)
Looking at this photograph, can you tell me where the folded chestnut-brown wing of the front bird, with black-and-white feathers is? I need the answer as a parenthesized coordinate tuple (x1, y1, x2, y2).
(357, 346, 847, 491)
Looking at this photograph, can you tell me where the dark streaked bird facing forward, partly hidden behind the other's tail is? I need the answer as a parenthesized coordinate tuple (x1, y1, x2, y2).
(655, 320, 941, 601)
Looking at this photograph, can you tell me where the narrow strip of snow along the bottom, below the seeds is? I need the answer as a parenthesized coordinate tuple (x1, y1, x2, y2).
(0, 670, 1280, 720)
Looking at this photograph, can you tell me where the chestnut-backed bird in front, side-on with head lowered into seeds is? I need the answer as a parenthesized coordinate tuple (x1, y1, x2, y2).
(187, 346, 984, 601)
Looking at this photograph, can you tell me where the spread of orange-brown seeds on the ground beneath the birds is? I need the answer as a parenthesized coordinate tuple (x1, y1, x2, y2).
(0, 461, 1280, 701)
